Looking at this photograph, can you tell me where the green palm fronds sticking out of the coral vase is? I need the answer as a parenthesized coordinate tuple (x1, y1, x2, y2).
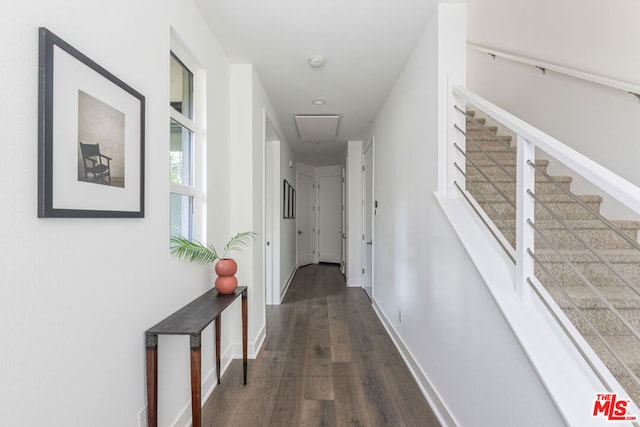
(171, 231, 256, 264)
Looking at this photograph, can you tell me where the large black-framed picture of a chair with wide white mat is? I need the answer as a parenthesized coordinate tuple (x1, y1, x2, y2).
(38, 28, 145, 218)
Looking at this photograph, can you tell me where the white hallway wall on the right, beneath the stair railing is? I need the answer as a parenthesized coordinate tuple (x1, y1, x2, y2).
(364, 3, 564, 426)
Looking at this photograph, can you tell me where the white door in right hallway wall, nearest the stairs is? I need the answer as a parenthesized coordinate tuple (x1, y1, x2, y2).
(362, 141, 375, 297)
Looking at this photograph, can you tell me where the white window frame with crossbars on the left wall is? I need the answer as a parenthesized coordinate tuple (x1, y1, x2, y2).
(167, 38, 206, 241)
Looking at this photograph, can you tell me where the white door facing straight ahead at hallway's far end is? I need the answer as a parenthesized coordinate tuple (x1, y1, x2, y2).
(317, 176, 342, 264)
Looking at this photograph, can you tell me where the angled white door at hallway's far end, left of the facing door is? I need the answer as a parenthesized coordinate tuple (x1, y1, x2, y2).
(296, 172, 314, 266)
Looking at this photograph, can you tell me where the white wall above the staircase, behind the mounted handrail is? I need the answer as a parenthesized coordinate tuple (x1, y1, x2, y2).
(468, 0, 640, 185)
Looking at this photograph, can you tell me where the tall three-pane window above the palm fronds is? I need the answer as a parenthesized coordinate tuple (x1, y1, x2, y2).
(169, 52, 197, 240)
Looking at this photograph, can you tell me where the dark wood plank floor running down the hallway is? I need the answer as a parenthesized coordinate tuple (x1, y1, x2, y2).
(203, 265, 439, 427)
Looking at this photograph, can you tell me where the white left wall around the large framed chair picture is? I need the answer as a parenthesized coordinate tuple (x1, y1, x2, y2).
(0, 0, 244, 427)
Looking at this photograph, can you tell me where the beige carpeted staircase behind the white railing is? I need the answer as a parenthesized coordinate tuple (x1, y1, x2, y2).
(466, 111, 640, 405)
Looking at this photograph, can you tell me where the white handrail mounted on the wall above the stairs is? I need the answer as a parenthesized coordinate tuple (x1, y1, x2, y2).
(467, 43, 640, 94)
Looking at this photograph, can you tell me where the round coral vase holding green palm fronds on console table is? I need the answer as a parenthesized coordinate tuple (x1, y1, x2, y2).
(171, 231, 256, 294)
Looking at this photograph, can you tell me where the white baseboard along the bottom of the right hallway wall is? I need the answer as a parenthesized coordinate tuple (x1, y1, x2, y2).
(371, 299, 458, 427)
